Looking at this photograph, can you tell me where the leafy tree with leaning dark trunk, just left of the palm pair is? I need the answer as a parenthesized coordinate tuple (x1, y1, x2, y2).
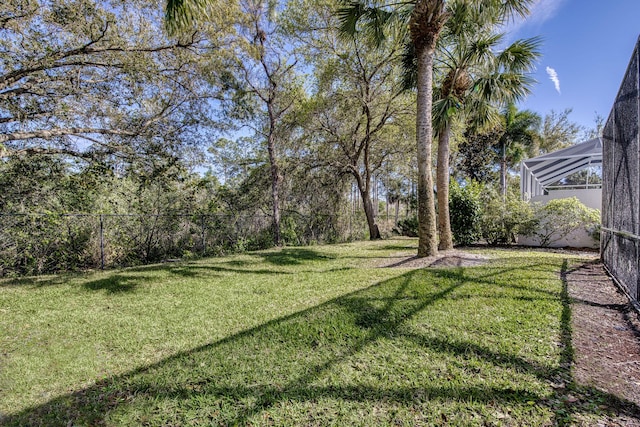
(291, 1, 413, 240)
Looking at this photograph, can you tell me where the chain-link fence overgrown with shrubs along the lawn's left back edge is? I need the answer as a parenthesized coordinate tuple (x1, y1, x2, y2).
(0, 213, 394, 277)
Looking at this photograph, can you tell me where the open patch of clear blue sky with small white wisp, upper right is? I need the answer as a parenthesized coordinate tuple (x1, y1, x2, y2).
(509, 0, 640, 134)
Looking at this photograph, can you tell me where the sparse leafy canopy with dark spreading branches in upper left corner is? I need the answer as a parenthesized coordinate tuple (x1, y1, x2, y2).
(0, 0, 222, 169)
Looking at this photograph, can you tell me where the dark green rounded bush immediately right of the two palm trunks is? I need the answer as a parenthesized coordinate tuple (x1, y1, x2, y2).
(449, 181, 482, 245)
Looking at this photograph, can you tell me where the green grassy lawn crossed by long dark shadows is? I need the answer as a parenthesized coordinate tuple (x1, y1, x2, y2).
(0, 239, 620, 426)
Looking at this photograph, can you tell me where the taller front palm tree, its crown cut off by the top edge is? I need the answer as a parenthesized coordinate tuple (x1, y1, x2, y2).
(339, 0, 532, 257)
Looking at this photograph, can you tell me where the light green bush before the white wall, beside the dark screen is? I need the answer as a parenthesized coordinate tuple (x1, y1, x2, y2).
(527, 197, 600, 247)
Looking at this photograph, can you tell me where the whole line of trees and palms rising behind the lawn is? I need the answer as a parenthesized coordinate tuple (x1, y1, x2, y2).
(0, 0, 600, 274)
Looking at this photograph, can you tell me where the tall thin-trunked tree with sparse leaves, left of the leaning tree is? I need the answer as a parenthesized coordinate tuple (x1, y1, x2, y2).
(166, 0, 301, 246)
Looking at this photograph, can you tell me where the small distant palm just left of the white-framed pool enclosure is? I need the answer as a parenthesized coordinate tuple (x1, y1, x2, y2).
(496, 104, 540, 199)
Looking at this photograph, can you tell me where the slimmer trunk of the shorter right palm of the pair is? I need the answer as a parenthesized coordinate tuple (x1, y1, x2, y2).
(436, 123, 453, 251)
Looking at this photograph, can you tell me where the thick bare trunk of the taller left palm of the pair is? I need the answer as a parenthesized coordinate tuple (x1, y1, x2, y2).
(416, 46, 438, 257)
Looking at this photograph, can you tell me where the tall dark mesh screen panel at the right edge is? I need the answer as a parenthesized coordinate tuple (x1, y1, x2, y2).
(601, 36, 640, 302)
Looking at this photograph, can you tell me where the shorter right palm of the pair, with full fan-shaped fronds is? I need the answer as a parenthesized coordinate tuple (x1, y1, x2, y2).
(433, 1, 540, 250)
